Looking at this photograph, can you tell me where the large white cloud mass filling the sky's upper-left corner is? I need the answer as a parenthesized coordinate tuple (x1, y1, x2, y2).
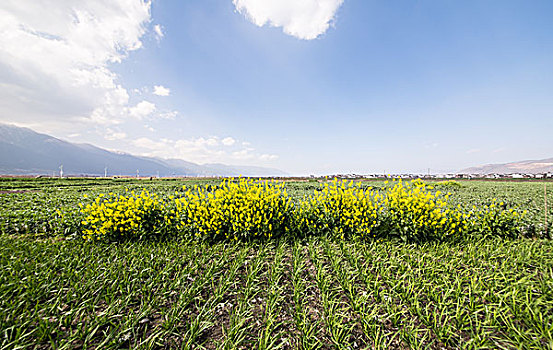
(0, 0, 151, 126)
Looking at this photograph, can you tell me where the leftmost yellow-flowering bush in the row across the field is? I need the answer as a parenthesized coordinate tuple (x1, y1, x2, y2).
(80, 190, 166, 239)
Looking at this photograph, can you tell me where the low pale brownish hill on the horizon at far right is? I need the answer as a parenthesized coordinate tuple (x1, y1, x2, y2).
(459, 158, 553, 175)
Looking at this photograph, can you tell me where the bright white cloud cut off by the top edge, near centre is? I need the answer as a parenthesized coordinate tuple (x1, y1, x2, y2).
(232, 0, 344, 40)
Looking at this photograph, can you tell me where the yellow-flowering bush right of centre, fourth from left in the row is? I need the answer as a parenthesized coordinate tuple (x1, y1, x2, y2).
(384, 179, 468, 240)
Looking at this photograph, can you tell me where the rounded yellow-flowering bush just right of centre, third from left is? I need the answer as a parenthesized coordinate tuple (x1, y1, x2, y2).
(297, 179, 384, 238)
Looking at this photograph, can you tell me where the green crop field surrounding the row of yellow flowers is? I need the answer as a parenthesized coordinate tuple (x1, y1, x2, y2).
(0, 179, 553, 349)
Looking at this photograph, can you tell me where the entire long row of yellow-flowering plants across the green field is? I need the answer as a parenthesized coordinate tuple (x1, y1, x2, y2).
(76, 178, 521, 241)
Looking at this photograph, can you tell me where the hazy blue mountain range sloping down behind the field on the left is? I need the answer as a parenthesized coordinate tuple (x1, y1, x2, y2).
(0, 124, 286, 176)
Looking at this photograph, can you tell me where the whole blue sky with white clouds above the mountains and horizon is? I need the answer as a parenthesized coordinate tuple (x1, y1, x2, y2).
(0, 0, 553, 175)
